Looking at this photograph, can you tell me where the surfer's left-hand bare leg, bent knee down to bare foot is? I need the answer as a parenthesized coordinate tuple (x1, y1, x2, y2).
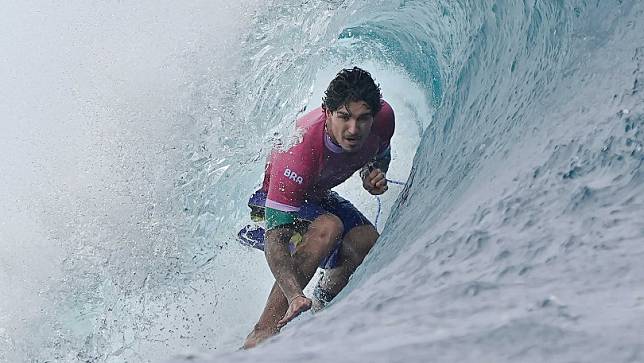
(243, 214, 342, 349)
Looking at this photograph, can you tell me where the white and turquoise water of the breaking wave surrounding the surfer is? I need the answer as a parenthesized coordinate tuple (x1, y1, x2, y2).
(0, 0, 644, 362)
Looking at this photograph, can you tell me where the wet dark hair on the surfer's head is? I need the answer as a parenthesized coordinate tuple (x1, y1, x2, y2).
(322, 67, 382, 115)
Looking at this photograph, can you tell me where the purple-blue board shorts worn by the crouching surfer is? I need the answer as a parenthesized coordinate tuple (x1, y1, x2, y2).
(238, 190, 373, 269)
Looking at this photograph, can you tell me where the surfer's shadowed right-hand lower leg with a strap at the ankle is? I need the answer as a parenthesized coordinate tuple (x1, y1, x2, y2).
(320, 225, 380, 304)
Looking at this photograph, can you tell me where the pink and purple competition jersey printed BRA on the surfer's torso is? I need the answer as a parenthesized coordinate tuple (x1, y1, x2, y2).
(262, 101, 394, 212)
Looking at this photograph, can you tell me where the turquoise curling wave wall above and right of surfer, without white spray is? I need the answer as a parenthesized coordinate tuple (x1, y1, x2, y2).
(201, 1, 644, 362)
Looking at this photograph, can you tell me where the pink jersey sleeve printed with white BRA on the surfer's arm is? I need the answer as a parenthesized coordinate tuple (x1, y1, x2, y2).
(266, 142, 318, 212)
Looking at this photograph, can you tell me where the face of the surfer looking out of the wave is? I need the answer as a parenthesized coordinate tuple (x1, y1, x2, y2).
(326, 101, 373, 152)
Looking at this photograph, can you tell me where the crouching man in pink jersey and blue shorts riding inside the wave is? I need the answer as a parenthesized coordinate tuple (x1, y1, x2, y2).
(240, 67, 394, 349)
